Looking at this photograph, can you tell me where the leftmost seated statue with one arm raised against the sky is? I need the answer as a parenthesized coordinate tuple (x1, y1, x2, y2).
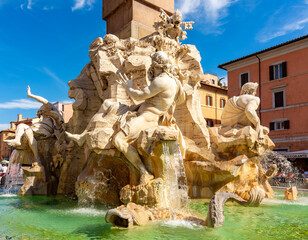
(5, 86, 64, 163)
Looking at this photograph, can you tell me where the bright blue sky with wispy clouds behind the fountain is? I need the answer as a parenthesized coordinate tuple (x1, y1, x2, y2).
(0, 0, 308, 130)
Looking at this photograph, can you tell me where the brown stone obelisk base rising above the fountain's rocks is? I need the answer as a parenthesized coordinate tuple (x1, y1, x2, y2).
(102, 0, 174, 39)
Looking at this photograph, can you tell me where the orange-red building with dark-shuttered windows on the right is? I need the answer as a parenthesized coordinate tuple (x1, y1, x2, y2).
(219, 35, 308, 152)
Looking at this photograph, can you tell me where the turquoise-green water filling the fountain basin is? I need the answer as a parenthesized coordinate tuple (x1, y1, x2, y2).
(0, 192, 308, 240)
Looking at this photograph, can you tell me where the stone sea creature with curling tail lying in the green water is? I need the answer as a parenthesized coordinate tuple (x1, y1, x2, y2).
(105, 187, 265, 228)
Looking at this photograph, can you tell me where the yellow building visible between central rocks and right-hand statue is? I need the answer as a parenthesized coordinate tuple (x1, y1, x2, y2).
(199, 73, 228, 127)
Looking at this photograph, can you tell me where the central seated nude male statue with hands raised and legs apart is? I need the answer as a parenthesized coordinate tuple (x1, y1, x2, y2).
(66, 52, 185, 184)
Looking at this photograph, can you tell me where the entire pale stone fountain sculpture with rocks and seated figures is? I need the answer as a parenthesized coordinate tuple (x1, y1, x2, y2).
(8, 10, 276, 227)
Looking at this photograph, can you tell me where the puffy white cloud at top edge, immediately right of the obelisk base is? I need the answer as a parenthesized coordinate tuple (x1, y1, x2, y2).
(177, 0, 238, 25)
